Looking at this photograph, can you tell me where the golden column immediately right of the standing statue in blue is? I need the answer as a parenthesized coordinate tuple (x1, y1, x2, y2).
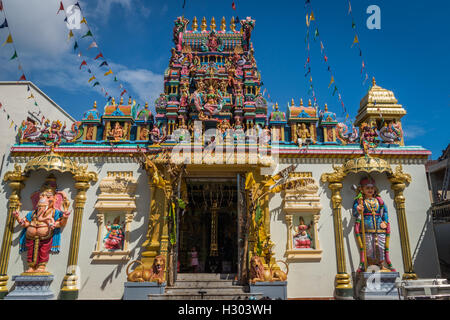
(389, 164, 417, 280)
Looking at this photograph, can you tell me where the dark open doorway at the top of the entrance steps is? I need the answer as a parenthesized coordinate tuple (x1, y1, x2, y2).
(177, 178, 238, 274)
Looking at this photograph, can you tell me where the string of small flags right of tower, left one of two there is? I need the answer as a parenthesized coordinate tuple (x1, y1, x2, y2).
(305, 1, 349, 120)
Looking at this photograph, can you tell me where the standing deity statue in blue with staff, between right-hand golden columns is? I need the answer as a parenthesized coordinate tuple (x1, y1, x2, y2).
(353, 177, 395, 272)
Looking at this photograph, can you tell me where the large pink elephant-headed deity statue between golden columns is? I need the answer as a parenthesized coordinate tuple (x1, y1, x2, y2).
(13, 176, 70, 273)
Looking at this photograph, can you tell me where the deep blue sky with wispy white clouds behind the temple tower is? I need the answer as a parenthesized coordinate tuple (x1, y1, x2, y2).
(0, 0, 450, 159)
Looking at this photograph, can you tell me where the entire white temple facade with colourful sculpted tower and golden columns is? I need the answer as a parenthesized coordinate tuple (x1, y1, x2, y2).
(0, 17, 439, 299)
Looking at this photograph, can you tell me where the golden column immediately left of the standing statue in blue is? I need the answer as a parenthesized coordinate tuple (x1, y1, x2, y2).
(320, 167, 353, 299)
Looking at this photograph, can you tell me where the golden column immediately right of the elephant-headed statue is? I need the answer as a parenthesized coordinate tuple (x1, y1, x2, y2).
(60, 166, 97, 300)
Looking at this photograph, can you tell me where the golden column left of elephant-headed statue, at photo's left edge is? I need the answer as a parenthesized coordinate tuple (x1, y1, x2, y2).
(0, 164, 26, 299)
